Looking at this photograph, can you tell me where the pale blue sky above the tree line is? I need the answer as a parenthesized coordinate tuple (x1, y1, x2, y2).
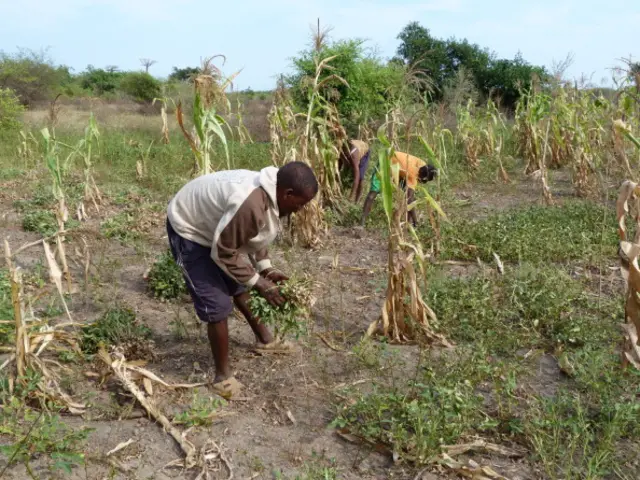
(0, 0, 640, 90)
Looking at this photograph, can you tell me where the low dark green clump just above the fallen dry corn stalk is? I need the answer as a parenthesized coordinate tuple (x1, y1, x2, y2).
(80, 307, 151, 355)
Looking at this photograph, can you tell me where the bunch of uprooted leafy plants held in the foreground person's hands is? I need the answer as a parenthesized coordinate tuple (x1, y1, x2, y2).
(249, 278, 313, 338)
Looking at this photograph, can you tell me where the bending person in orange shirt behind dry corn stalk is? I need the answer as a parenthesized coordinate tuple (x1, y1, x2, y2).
(361, 152, 438, 227)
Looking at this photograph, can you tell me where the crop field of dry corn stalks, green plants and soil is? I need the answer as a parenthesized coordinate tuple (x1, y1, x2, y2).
(0, 50, 640, 480)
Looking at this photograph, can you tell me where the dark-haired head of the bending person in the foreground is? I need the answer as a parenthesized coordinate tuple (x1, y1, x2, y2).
(276, 162, 318, 217)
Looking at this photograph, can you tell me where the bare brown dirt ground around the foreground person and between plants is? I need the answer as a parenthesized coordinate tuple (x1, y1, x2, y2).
(0, 167, 624, 480)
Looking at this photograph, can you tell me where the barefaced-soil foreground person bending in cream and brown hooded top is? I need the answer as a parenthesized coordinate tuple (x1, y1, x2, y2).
(167, 162, 318, 396)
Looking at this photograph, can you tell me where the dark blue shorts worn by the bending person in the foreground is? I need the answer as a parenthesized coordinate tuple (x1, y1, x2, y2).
(167, 219, 246, 323)
